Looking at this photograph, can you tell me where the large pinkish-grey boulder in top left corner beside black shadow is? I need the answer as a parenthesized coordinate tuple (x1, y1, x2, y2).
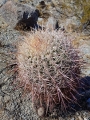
(0, 0, 35, 27)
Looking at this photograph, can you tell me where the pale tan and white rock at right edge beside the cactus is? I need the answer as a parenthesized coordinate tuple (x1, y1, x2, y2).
(72, 33, 90, 76)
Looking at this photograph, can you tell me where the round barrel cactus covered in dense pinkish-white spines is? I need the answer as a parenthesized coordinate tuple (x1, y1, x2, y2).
(17, 30, 81, 116)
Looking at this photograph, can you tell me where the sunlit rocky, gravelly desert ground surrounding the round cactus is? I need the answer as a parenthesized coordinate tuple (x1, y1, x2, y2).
(0, 0, 90, 120)
